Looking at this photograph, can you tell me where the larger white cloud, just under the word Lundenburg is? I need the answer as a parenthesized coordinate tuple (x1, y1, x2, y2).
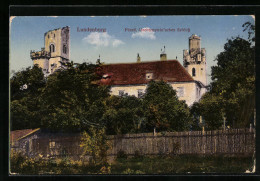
(83, 32, 124, 47)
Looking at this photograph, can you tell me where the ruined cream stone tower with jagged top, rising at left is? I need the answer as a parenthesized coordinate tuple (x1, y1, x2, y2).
(30, 26, 70, 76)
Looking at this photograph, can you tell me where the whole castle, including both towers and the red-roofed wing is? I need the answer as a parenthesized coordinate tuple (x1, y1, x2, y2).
(30, 26, 207, 106)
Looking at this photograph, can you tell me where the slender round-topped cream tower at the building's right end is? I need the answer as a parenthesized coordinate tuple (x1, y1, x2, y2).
(183, 34, 207, 86)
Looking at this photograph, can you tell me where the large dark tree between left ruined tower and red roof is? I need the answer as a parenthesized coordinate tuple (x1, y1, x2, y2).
(40, 63, 109, 131)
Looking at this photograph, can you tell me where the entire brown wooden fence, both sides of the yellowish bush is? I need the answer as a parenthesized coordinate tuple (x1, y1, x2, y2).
(23, 129, 255, 158)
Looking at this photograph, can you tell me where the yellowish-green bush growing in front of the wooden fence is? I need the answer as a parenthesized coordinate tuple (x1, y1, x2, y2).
(80, 127, 110, 165)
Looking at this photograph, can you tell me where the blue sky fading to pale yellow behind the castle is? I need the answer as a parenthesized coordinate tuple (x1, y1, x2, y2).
(9, 15, 255, 80)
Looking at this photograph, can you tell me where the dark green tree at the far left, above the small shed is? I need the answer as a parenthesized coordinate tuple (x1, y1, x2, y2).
(10, 66, 46, 130)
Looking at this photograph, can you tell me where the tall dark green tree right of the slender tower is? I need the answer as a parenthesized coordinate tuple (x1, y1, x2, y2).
(212, 37, 255, 128)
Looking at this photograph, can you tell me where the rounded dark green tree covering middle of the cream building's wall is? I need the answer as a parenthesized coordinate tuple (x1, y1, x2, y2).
(144, 81, 191, 131)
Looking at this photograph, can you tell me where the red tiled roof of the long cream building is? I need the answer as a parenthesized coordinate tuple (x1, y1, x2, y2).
(98, 60, 194, 85)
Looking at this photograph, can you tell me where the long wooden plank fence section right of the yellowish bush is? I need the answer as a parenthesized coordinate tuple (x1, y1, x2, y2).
(105, 129, 255, 155)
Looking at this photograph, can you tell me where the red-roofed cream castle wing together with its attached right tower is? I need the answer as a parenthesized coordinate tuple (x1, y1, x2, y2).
(100, 35, 207, 106)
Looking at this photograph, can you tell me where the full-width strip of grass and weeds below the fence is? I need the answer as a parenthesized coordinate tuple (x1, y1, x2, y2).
(11, 151, 253, 175)
